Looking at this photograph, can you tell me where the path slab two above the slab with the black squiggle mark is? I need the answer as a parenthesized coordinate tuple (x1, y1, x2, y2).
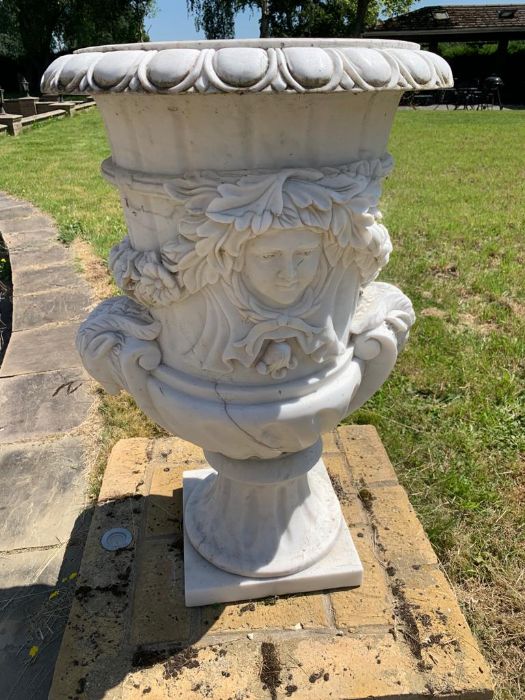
(13, 286, 91, 334)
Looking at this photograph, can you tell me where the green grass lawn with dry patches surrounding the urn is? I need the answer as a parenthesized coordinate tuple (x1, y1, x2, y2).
(0, 106, 525, 700)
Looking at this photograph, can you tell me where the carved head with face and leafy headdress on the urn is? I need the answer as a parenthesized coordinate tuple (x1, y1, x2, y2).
(161, 159, 389, 308)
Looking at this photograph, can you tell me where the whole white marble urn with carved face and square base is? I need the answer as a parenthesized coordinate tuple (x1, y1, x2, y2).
(42, 39, 452, 605)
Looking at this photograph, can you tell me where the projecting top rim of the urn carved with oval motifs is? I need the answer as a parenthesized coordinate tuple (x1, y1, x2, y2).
(41, 40, 453, 94)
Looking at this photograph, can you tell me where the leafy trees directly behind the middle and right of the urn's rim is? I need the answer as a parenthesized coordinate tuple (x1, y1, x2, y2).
(187, 0, 414, 39)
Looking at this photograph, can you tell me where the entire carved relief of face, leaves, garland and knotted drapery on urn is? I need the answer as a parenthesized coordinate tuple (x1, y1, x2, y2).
(105, 155, 400, 378)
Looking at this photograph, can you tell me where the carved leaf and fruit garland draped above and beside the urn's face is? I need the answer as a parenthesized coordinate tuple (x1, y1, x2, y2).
(109, 156, 392, 306)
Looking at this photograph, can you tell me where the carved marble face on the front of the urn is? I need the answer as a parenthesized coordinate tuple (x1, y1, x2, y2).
(242, 229, 322, 307)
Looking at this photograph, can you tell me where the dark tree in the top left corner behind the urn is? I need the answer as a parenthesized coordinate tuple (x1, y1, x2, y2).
(0, 0, 155, 89)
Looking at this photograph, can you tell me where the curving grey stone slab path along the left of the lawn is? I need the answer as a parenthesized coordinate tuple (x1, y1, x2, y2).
(0, 193, 97, 700)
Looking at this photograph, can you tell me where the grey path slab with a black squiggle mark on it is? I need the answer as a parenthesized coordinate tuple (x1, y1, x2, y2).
(0, 369, 93, 445)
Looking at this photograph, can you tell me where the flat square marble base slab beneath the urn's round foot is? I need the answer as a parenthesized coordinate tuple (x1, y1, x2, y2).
(182, 469, 363, 607)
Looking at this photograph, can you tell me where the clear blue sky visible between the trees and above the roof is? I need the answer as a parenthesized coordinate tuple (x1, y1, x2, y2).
(146, 0, 521, 41)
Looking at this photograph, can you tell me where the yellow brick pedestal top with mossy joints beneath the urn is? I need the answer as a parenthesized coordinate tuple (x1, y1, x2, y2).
(50, 426, 492, 700)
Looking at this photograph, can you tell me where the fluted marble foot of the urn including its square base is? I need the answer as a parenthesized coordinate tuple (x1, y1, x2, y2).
(183, 441, 362, 605)
